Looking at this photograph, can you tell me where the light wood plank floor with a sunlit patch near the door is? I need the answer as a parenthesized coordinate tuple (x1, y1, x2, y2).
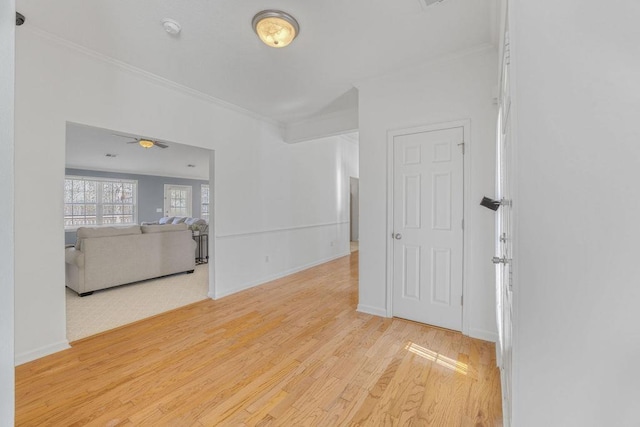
(16, 252, 501, 426)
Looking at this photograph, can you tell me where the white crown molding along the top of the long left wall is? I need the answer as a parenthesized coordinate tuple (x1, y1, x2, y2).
(21, 26, 285, 131)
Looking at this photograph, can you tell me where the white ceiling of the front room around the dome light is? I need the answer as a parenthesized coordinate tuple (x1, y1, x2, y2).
(17, 0, 495, 124)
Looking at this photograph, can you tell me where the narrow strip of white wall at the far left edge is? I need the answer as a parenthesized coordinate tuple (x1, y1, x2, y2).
(0, 0, 16, 426)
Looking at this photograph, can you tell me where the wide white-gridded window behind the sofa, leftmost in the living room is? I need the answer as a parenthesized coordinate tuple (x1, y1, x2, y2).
(64, 176, 138, 228)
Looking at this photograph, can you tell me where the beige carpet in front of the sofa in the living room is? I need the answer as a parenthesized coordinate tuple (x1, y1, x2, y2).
(66, 264, 209, 342)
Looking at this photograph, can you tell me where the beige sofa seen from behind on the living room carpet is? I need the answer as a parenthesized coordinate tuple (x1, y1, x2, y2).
(65, 224, 196, 296)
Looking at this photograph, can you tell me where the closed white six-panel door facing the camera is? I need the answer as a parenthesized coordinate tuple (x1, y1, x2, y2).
(390, 127, 464, 331)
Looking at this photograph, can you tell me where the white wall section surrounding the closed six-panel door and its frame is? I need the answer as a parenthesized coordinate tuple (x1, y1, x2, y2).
(358, 49, 497, 340)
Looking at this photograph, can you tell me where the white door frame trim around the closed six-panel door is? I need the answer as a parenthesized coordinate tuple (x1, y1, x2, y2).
(385, 119, 472, 335)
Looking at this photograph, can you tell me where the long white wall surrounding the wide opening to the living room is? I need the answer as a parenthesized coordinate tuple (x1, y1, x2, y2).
(15, 28, 356, 363)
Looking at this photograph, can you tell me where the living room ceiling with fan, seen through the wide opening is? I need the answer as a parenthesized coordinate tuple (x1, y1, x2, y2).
(66, 123, 211, 180)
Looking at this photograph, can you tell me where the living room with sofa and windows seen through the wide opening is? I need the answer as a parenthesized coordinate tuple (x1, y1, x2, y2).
(64, 123, 214, 342)
